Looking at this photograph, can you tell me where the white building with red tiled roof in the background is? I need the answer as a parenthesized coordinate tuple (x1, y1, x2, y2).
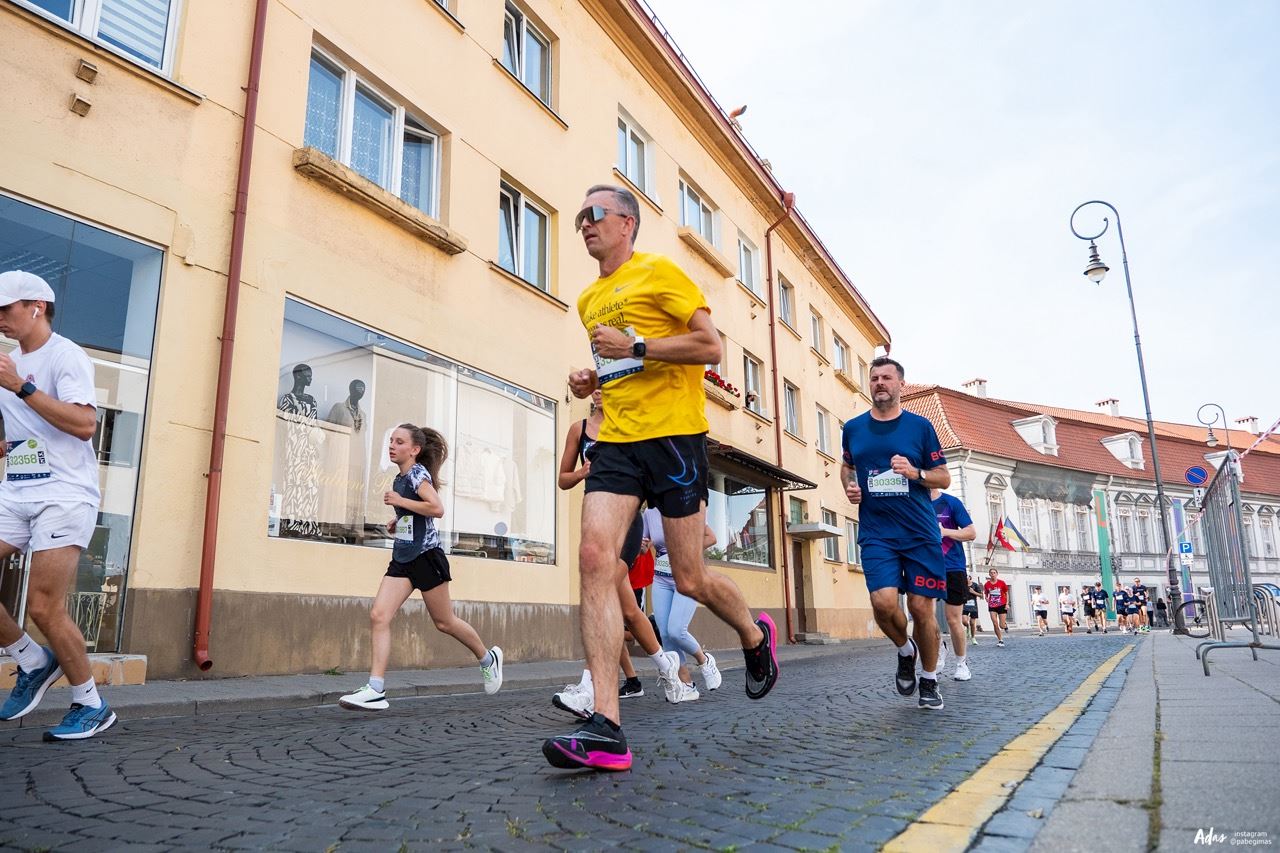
(902, 380, 1280, 628)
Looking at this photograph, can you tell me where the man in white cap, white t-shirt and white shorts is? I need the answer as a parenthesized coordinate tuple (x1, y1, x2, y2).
(0, 270, 115, 740)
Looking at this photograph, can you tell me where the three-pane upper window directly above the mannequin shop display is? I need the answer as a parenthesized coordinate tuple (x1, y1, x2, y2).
(302, 51, 440, 216)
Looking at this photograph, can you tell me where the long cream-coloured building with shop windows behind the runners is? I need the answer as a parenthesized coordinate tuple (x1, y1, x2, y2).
(0, 0, 888, 678)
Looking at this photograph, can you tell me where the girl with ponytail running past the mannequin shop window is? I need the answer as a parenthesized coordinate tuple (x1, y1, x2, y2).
(338, 424, 502, 711)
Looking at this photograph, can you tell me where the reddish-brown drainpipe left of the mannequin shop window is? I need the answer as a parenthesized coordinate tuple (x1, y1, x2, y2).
(192, 0, 268, 671)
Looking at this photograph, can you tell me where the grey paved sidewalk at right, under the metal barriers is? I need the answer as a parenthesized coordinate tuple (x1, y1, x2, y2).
(1008, 631, 1280, 853)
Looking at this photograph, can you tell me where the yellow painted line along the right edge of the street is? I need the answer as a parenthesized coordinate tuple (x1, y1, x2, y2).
(883, 646, 1134, 853)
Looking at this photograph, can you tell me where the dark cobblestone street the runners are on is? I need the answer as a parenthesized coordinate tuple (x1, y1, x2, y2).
(0, 635, 1132, 850)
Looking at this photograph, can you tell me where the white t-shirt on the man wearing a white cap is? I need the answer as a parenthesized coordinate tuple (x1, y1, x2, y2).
(0, 333, 101, 506)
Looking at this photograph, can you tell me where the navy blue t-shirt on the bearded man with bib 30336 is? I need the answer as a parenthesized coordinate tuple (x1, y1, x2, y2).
(840, 411, 947, 548)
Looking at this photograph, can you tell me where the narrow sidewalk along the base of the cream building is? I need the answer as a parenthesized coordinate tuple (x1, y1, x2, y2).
(7, 639, 870, 727)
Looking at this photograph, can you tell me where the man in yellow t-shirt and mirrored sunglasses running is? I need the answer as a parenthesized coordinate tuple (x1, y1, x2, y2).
(543, 186, 778, 770)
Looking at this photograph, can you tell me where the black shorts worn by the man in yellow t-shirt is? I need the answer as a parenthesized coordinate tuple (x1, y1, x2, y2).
(586, 433, 707, 519)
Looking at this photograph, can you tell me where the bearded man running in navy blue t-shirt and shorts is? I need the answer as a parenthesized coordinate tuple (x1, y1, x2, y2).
(840, 356, 951, 710)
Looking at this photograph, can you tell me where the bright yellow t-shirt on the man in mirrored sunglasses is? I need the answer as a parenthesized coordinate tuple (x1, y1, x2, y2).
(577, 252, 710, 442)
